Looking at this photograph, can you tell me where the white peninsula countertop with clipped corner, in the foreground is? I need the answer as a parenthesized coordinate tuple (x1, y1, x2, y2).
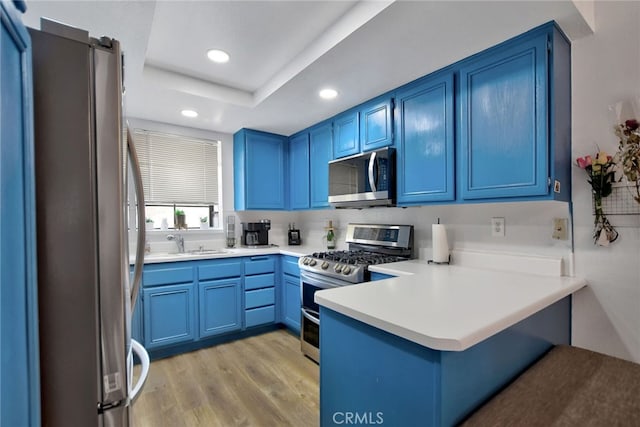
(315, 260, 587, 351)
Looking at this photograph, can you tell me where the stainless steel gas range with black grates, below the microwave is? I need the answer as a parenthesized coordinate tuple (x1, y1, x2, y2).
(298, 224, 413, 362)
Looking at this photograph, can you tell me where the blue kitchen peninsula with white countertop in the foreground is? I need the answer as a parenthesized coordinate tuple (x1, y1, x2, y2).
(315, 260, 586, 426)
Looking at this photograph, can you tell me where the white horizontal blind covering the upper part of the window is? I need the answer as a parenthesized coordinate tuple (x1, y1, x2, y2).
(133, 129, 219, 205)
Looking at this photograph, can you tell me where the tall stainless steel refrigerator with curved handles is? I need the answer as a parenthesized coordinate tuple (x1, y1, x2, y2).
(29, 19, 148, 427)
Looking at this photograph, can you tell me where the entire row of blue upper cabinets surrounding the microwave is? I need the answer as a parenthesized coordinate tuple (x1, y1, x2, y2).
(234, 23, 571, 209)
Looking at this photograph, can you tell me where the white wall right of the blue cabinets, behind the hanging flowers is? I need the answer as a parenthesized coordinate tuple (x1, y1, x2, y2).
(572, 2, 640, 362)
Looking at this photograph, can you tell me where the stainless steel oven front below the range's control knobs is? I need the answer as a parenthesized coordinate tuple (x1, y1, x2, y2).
(300, 269, 353, 363)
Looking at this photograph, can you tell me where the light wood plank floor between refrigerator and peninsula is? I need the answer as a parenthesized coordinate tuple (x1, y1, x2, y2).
(133, 329, 319, 427)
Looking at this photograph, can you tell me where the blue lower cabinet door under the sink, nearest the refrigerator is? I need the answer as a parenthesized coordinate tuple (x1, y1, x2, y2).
(143, 283, 196, 349)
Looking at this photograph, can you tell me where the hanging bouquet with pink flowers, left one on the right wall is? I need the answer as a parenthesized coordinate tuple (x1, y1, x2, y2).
(577, 151, 618, 246)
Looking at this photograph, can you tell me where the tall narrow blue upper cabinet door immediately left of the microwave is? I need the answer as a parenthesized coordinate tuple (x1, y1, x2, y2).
(309, 122, 333, 208)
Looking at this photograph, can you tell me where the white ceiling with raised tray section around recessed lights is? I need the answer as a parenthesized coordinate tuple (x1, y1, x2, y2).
(25, 0, 592, 135)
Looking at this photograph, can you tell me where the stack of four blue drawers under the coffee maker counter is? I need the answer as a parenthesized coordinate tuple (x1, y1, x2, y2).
(244, 255, 276, 328)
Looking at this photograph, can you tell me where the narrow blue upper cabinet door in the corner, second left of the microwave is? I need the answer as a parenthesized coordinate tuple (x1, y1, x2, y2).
(289, 132, 311, 209)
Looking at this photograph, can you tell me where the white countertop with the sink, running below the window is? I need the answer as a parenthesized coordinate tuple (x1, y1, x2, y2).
(130, 245, 323, 264)
